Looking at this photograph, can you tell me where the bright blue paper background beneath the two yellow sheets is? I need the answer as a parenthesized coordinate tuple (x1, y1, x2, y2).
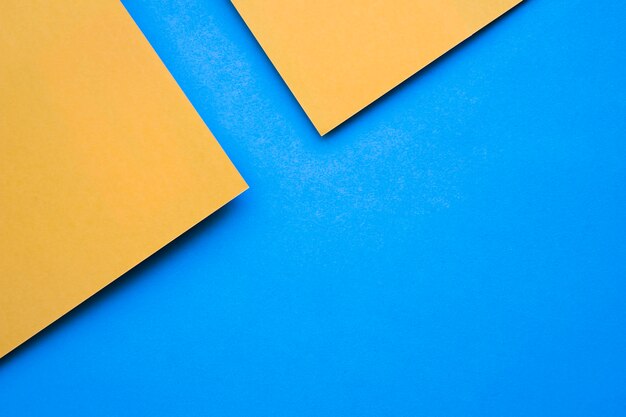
(0, 0, 626, 417)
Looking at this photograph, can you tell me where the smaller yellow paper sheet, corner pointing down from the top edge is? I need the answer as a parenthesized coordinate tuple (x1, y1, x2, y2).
(232, 0, 521, 134)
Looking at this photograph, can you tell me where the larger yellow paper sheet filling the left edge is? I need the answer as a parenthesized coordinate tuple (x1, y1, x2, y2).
(0, 0, 246, 357)
